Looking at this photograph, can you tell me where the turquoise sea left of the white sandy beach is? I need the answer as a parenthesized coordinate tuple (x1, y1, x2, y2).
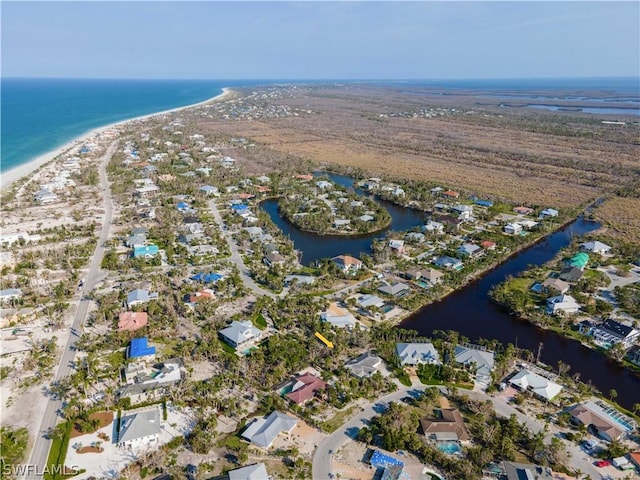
(0, 78, 258, 171)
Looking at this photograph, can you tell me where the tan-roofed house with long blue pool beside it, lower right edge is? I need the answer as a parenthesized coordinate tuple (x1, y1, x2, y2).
(567, 401, 637, 442)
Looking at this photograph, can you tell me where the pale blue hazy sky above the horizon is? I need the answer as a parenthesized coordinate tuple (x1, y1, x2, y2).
(0, 1, 640, 79)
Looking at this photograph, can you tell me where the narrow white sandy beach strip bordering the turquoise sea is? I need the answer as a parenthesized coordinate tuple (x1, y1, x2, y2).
(0, 87, 233, 193)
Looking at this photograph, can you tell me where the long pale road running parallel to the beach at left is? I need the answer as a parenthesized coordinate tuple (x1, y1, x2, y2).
(26, 142, 117, 480)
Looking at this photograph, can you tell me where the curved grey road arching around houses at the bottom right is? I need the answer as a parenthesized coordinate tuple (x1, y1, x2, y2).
(312, 384, 601, 480)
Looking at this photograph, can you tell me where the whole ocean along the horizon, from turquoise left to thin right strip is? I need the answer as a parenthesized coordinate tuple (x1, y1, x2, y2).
(0, 78, 640, 172)
